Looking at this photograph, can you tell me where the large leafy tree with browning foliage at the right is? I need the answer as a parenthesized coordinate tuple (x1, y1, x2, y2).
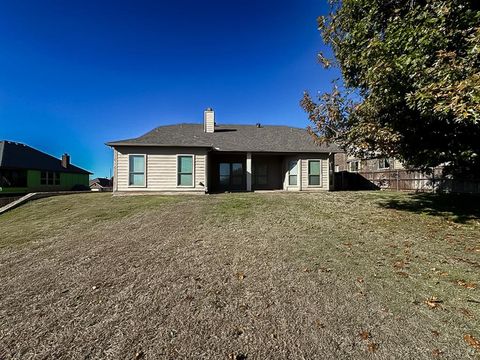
(301, 0, 480, 176)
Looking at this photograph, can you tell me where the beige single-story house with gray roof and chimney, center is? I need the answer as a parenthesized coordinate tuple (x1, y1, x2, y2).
(107, 109, 339, 193)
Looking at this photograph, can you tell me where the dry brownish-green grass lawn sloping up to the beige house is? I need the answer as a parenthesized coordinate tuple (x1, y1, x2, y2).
(0, 192, 480, 359)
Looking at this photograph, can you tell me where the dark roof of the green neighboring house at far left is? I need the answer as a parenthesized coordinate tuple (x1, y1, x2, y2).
(0, 141, 90, 174)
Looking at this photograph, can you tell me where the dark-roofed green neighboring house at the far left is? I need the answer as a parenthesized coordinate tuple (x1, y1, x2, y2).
(0, 141, 90, 194)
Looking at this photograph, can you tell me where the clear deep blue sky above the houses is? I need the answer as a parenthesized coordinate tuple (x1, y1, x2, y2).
(0, 0, 338, 176)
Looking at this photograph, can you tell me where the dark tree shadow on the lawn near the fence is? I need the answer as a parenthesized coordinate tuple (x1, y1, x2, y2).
(380, 193, 480, 224)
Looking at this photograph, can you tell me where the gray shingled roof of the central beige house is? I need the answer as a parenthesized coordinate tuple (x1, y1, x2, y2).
(107, 124, 340, 153)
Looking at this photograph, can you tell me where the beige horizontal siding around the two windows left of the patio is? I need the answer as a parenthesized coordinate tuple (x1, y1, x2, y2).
(115, 147, 207, 191)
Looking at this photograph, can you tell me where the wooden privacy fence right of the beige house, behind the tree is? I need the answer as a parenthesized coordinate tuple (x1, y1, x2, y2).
(335, 170, 480, 193)
